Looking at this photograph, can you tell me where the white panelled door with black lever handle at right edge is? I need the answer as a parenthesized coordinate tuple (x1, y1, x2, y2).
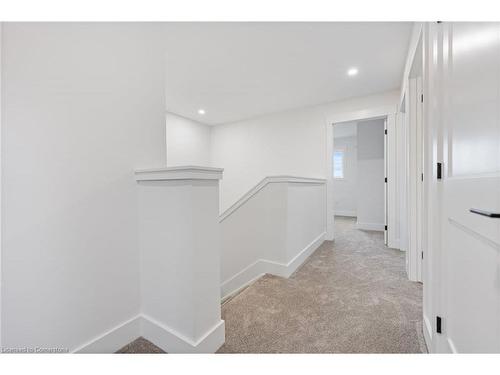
(437, 23, 500, 353)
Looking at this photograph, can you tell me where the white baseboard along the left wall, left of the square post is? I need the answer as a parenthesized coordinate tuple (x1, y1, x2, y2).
(72, 315, 141, 353)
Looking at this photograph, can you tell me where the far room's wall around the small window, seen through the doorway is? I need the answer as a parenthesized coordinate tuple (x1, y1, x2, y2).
(334, 131, 358, 216)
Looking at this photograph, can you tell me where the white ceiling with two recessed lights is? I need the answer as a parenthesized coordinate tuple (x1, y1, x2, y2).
(162, 22, 412, 124)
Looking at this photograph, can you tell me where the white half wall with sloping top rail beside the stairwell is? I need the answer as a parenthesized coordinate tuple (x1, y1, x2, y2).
(220, 176, 326, 297)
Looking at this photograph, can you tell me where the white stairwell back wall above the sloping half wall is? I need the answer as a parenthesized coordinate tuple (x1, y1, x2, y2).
(212, 108, 325, 212)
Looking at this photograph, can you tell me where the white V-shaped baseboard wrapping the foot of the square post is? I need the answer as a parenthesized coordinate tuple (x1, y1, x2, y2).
(141, 314, 225, 353)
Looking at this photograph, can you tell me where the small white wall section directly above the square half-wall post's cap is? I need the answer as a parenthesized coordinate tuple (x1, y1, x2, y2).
(165, 112, 211, 167)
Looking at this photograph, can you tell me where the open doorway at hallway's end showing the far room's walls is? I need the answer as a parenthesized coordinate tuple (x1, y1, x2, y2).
(331, 117, 388, 245)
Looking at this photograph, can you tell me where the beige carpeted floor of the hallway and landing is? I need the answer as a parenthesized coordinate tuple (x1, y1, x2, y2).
(120, 217, 426, 353)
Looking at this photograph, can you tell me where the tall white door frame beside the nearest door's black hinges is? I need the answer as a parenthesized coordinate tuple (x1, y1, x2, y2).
(422, 22, 443, 353)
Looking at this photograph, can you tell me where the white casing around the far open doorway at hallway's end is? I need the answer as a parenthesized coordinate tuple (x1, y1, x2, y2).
(325, 106, 397, 247)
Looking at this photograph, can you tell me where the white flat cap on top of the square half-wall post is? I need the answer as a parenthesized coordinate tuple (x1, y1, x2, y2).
(134, 165, 224, 181)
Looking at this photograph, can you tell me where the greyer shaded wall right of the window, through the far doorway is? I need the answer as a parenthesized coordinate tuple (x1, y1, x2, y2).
(357, 119, 385, 230)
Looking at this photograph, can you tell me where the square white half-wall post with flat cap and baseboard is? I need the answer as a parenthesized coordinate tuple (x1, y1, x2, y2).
(136, 167, 224, 353)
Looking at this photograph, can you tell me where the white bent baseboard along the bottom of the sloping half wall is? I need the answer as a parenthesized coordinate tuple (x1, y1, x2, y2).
(221, 232, 326, 300)
